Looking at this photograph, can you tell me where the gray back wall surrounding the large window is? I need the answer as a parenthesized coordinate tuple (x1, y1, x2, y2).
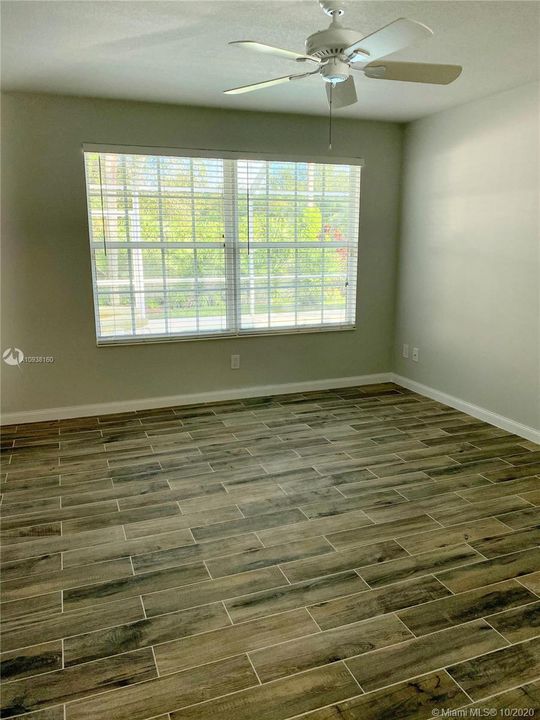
(2, 94, 402, 412)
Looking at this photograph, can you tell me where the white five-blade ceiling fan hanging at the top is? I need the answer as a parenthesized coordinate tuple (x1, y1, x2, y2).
(224, 0, 462, 108)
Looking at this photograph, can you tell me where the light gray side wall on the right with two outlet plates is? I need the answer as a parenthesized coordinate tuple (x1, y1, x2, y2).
(395, 85, 540, 428)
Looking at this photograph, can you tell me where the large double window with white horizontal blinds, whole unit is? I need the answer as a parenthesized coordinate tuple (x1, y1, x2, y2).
(85, 149, 360, 344)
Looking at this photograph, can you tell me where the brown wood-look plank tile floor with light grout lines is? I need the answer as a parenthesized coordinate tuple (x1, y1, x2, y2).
(1, 384, 540, 720)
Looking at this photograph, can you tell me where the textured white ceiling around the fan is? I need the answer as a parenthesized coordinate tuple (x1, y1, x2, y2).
(1, 0, 540, 121)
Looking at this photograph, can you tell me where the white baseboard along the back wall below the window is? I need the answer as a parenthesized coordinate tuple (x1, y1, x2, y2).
(2, 373, 392, 425)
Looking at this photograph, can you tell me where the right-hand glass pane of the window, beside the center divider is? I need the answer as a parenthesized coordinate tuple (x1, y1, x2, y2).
(237, 161, 359, 331)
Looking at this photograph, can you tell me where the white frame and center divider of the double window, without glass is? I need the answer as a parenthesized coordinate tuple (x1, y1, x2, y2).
(81, 143, 365, 347)
